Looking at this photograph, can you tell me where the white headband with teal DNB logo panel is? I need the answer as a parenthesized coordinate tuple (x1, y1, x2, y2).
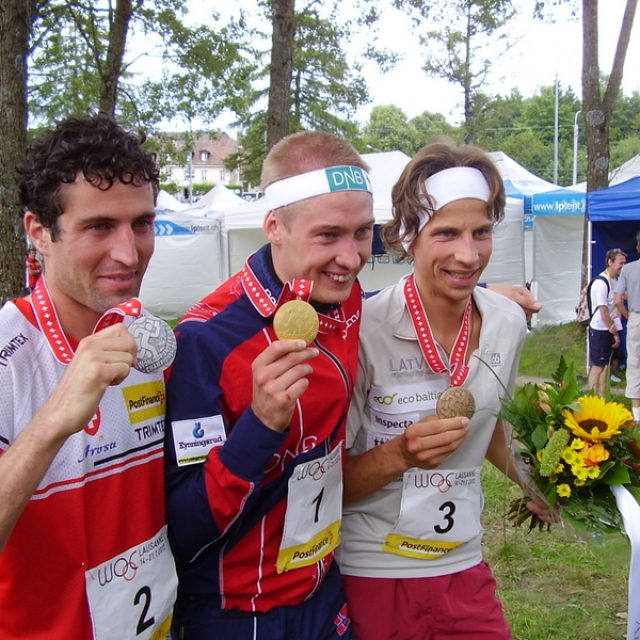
(264, 165, 373, 210)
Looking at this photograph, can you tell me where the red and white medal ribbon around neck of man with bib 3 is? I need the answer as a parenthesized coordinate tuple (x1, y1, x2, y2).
(404, 273, 472, 387)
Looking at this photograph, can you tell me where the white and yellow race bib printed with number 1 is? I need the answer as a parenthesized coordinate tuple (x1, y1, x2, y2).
(277, 444, 342, 573)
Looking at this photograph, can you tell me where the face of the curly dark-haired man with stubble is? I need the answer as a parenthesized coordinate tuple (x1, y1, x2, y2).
(25, 176, 155, 339)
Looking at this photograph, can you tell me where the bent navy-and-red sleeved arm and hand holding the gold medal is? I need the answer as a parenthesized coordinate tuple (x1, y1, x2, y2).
(165, 322, 314, 560)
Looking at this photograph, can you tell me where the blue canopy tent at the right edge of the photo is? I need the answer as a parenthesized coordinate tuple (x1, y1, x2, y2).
(587, 176, 640, 273)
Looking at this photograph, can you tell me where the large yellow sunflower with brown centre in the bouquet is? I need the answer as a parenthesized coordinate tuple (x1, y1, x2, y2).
(562, 395, 633, 442)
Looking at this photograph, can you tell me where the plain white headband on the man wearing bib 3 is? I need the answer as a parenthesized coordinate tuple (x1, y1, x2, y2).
(400, 167, 491, 253)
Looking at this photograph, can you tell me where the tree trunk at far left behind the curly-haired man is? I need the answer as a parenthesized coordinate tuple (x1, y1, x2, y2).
(0, 0, 36, 303)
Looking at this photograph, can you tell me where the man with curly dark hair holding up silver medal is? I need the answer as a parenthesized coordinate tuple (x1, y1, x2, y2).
(0, 115, 176, 640)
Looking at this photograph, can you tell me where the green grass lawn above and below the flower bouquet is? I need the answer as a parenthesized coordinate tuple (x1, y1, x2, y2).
(490, 322, 631, 640)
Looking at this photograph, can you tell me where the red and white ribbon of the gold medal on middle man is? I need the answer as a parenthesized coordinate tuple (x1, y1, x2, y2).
(241, 261, 345, 333)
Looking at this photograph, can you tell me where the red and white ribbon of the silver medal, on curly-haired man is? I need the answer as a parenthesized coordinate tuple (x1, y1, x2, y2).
(31, 274, 142, 435)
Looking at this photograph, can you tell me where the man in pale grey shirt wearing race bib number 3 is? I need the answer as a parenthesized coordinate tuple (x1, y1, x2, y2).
(338, 142, 546, 640)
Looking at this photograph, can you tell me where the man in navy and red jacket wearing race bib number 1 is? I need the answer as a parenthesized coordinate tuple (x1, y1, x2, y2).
(166, 132, 374, 640)
